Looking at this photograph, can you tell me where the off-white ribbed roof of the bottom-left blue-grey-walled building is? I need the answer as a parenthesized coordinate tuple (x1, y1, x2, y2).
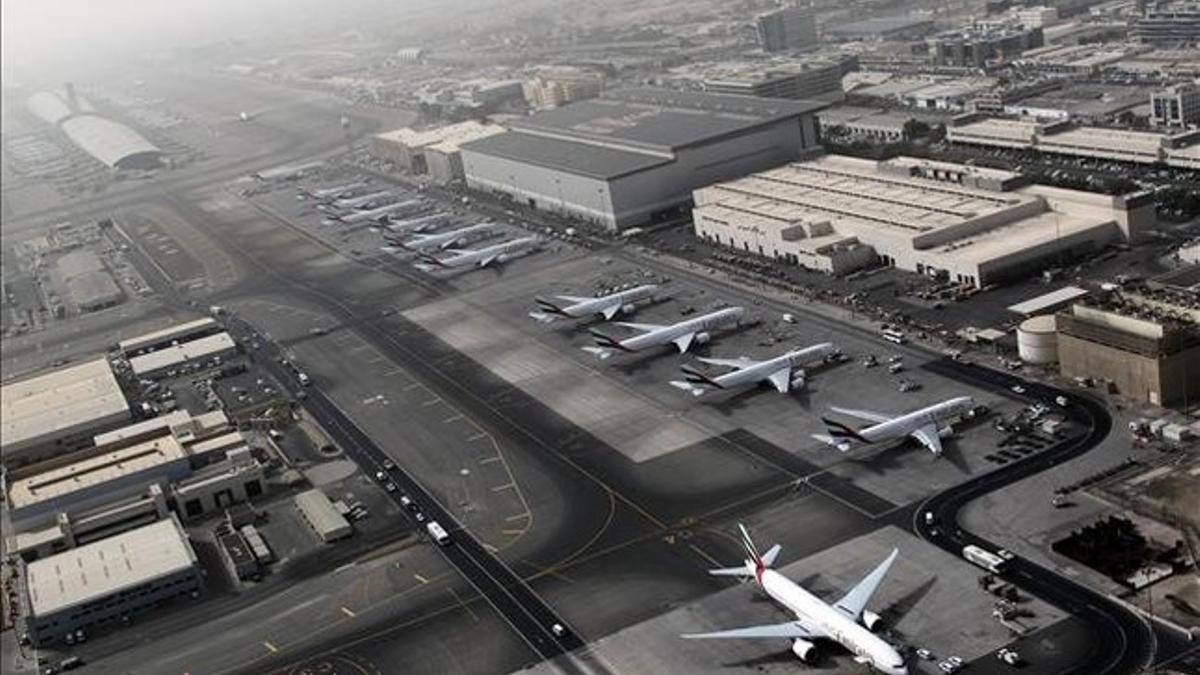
(25, 515, 197, 616)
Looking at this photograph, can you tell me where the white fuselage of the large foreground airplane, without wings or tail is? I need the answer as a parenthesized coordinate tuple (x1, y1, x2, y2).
(755, 569, 908, 675)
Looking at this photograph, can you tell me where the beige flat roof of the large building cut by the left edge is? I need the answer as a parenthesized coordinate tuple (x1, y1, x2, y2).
(0, 359, 130, 452)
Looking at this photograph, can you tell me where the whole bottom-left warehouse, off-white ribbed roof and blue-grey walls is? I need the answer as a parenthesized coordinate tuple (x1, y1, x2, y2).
(25, 516, 204, 646)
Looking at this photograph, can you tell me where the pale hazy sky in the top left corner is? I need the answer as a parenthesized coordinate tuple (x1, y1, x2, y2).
(0, 0, 360, 72)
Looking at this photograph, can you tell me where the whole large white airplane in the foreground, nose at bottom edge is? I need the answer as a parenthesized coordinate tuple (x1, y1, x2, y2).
(683, 525, 908, 675)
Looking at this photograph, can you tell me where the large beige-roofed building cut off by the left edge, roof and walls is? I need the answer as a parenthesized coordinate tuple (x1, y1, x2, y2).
(0, 359, 130, 468)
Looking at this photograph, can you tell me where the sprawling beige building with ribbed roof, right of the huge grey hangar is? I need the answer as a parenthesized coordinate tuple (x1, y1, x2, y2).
(692, 156, 1156, 287)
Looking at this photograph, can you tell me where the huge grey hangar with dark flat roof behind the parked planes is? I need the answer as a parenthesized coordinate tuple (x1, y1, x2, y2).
(461, 89, 821, 229)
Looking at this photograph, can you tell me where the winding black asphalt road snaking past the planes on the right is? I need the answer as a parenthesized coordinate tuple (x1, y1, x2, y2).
(912, 359, 1156, 675)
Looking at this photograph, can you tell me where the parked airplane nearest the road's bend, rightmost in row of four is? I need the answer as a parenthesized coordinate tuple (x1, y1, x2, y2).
(812, 396, 974, 455)
